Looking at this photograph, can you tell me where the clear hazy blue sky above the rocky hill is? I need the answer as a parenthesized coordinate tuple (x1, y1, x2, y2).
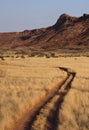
(0, 0, 89, 32)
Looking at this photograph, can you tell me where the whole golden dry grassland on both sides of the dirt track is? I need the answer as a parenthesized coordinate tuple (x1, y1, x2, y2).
(0, 57, 89, 130)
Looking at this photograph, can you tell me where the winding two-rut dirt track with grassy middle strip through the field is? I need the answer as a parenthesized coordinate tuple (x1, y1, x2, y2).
(22, 67, 76, 130)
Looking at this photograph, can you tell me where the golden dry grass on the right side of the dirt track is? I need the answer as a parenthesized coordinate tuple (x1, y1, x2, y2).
(58, 57, 89, 130)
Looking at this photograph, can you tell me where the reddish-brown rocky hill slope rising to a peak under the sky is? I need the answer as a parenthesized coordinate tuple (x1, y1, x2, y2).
(0, 14, 89, 50)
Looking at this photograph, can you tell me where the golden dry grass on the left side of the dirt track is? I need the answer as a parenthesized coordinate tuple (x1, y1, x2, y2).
(0, 58, 66, 130)
